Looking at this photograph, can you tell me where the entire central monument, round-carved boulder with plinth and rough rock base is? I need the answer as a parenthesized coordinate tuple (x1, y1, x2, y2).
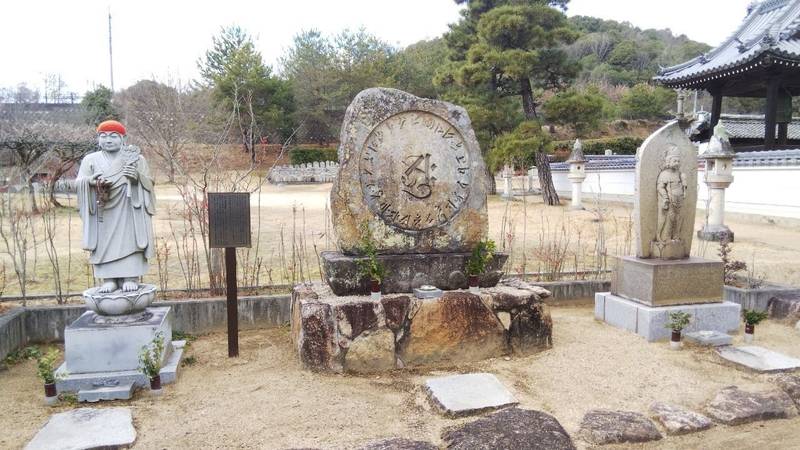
(291, 88, 552, 373)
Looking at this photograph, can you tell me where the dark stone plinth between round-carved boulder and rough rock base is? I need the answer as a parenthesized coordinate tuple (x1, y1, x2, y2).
(320, 252, 508, 295)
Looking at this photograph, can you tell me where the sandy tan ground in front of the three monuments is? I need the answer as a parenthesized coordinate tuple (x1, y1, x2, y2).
(0, 305, 800, 450)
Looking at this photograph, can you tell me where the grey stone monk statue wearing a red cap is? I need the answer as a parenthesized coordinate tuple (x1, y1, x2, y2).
(75, 120, 155, 314)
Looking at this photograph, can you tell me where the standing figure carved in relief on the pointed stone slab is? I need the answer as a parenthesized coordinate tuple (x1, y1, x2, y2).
(652, 145, 688, 258)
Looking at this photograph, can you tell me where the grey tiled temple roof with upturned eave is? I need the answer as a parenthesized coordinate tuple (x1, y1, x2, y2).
(653, 0, 800, 89)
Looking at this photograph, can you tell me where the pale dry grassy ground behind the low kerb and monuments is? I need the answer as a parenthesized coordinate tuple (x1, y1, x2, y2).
(2, 179, 800, 296)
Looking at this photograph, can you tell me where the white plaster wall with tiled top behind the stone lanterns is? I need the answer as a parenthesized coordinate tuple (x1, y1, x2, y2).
(548, 166, 800, 219)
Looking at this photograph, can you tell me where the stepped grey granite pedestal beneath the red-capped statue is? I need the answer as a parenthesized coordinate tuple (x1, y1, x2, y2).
(56, 307, 184, 401)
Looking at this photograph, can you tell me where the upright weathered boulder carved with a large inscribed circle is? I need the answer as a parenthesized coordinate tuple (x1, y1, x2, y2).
(331, 88, 489, 255)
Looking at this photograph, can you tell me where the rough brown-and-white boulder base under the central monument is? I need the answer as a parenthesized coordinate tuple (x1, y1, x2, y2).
(291, 284, 553, 373)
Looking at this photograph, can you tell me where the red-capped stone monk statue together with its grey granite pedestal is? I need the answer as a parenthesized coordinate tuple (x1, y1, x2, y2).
(57, 120, 181, 401)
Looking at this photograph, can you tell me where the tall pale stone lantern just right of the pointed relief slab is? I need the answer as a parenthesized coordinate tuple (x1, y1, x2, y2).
(697, 123, 736, 242)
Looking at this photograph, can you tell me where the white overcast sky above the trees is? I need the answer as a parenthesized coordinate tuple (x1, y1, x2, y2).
(0, 0, 751, 93)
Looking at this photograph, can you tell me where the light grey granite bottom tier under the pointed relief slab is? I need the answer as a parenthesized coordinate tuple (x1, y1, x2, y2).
(594, 292, 741, 342)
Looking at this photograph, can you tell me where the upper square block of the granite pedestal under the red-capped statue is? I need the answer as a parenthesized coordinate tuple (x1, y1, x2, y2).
(64, 307, 172, 374)
